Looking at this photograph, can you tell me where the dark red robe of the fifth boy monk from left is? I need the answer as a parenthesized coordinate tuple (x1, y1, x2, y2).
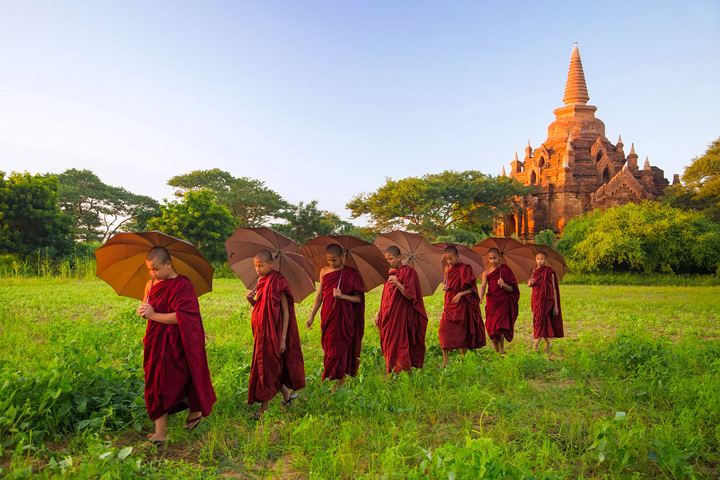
(438, 262, 486, 350)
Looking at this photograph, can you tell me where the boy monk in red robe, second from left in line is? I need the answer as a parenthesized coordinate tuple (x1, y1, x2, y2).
(245, 250, 305, 419)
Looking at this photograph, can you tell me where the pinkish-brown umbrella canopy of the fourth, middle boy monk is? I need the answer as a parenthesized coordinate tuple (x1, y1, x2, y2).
(375, 230, 443, 297)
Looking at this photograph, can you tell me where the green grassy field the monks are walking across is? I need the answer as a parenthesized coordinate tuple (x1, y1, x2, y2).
(0, 279, 720, 479)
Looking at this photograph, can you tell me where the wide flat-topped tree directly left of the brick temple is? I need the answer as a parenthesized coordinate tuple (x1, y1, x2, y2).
(347, 170, 529, 240)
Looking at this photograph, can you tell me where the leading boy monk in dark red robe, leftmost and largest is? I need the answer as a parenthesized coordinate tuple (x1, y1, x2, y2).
(137, 247, 216, 445)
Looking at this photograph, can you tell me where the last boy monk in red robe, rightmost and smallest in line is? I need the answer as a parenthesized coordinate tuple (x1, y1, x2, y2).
(528, 252, 564, 352)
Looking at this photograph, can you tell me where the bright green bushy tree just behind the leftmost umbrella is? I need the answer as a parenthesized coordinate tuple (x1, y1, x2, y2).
(148, 190, 235, 264)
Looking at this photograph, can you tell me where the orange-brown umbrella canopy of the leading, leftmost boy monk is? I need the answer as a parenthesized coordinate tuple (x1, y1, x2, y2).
(95, 231, 215, 301)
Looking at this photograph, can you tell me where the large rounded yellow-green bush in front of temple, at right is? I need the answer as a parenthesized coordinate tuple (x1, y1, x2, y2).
(557, 202, 720, 273)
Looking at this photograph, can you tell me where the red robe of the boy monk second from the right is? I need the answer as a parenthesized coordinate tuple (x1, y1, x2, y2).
(485, 264, 520, 342)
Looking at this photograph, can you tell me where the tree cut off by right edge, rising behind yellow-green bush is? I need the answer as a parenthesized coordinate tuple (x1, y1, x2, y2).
(665, 138, 720, 223)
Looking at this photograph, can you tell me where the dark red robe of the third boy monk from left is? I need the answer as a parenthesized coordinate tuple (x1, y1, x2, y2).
(320, 265, 365, 380)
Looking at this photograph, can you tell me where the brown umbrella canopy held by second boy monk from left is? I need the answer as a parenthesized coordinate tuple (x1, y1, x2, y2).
(225, 227, 315, 303)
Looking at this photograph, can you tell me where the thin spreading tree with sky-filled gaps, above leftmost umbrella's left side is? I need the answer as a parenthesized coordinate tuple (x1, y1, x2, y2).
(57, 168, 160, 242)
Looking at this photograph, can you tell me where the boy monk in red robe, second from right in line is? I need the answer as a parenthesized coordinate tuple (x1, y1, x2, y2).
(480, 248, 520, 355)
